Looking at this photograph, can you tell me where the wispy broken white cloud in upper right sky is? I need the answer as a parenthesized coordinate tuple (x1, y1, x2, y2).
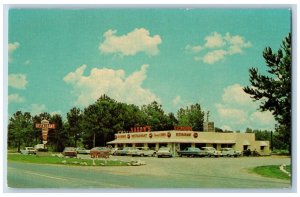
(185, 32, 252, 64)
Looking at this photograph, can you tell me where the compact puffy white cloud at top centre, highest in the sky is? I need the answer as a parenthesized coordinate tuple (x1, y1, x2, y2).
(99, 28, 162, 56)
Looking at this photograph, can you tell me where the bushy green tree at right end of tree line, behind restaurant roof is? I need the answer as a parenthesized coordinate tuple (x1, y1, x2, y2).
(177, 103, 204, 131)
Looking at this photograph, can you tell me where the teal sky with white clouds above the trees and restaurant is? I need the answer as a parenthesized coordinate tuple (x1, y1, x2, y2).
(8, 8, 291, 131)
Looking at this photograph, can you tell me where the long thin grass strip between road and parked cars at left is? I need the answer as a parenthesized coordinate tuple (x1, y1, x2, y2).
(7, 154, 128, 166)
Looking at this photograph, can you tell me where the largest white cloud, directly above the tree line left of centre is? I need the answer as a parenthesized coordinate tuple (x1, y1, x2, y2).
(63, 64, 160, 106)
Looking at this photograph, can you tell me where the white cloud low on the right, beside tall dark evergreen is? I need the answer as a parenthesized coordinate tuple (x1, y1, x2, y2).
(215, 84, 275, 130)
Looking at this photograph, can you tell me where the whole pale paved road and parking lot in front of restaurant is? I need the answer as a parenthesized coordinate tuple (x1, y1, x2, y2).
(7, 156, 291, 189)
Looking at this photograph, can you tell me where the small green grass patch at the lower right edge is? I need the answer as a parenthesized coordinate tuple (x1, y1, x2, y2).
(251, 165, 291, 180)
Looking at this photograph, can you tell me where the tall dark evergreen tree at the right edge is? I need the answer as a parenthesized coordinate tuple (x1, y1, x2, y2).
(244, 34, 292, 151)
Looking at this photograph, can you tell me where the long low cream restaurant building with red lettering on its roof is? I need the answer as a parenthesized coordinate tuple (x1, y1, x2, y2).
(107, 122, 270, 156)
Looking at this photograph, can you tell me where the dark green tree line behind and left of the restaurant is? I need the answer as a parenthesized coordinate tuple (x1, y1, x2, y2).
(8, 95, 204, 151)
